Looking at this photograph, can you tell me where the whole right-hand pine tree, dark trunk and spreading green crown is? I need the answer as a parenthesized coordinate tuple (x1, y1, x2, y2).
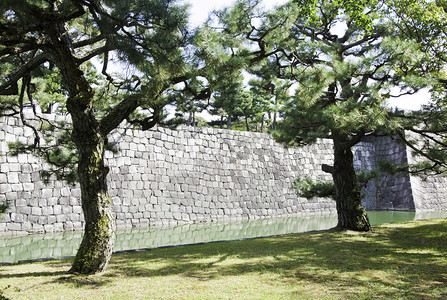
(215, 0, 446, 231)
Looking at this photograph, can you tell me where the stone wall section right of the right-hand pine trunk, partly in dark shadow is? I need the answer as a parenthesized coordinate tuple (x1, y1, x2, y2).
(354, 132, 447, 212)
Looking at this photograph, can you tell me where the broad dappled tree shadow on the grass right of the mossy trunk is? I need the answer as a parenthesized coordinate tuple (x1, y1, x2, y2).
(105, 222, 447, 298)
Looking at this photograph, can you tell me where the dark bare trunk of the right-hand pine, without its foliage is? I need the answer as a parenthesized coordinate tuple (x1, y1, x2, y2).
(332, 134, 371, 231)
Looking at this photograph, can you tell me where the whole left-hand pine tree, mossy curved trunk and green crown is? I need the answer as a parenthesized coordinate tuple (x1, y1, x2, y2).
(0, 0, 191, 274)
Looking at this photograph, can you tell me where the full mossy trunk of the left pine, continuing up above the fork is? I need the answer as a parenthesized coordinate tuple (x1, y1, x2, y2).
(46, 25, 116, 274)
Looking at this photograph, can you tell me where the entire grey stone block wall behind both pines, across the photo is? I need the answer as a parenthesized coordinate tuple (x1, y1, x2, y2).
(0, 116, 447, 234)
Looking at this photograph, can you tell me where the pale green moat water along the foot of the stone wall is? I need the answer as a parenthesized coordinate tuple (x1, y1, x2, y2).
(0, 211, 447, 264)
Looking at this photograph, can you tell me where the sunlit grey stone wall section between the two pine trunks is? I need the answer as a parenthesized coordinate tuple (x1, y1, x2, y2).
(107, 122, 334, 227)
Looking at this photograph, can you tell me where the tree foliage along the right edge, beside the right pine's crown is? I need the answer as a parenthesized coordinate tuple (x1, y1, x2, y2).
(384, 0, 447, 175)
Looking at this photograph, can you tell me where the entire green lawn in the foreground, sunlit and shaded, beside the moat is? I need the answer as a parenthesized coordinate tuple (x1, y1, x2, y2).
(0, 219, 447, 299)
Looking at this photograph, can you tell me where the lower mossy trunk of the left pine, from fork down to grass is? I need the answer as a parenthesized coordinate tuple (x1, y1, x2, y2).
(70, 110, 115, 274)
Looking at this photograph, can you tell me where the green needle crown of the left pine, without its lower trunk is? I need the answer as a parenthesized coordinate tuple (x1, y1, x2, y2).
(0, 0, 190, 123)
